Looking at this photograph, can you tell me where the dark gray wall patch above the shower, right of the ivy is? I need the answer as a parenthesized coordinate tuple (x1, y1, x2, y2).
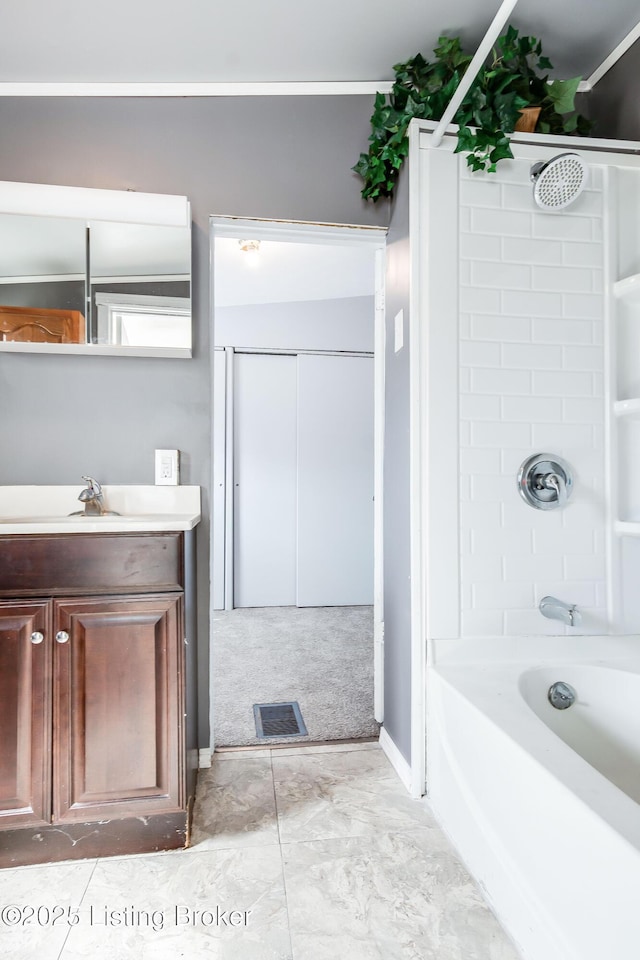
(587, 40, 640, 140)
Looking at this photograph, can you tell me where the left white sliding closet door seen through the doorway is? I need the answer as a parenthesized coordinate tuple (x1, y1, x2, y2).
(234, 354, 296, 607)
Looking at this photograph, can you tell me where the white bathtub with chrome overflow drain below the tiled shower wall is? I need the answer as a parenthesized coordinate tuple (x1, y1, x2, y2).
(427, 637, 640, 960)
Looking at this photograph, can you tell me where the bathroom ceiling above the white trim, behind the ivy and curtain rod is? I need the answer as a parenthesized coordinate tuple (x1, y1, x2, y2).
(0, 0, 640, 83)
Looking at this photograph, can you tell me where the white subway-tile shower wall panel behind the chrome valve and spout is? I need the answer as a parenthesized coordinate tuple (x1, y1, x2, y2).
(459, 160, 607, 636)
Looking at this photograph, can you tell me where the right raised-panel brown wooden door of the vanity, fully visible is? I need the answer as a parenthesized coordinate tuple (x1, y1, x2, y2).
(53, 594, 184, 821)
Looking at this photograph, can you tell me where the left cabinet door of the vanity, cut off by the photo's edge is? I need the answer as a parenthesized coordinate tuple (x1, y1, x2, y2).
(0, 601, 51, 828)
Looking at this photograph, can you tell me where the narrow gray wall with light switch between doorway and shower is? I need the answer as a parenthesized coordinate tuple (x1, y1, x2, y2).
(384, 170, 411, 763)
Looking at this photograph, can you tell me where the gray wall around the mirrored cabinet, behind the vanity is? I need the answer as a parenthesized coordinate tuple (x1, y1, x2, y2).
(0, 97, 387, 746)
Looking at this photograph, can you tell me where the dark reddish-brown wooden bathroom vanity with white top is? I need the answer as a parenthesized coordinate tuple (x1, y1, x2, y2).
(0, 487, 200, 867)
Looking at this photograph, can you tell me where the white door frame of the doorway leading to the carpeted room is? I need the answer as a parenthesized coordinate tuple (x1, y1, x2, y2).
(209, 215, 387, 752)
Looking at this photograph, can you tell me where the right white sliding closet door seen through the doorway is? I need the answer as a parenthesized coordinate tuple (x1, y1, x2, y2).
(297, 355, 374, 607)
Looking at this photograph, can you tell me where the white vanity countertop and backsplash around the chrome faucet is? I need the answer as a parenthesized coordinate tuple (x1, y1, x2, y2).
(0, 484, 201, 536)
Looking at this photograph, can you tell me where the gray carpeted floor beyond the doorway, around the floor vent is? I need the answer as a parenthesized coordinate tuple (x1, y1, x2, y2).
(213, 607, 379, 747)
